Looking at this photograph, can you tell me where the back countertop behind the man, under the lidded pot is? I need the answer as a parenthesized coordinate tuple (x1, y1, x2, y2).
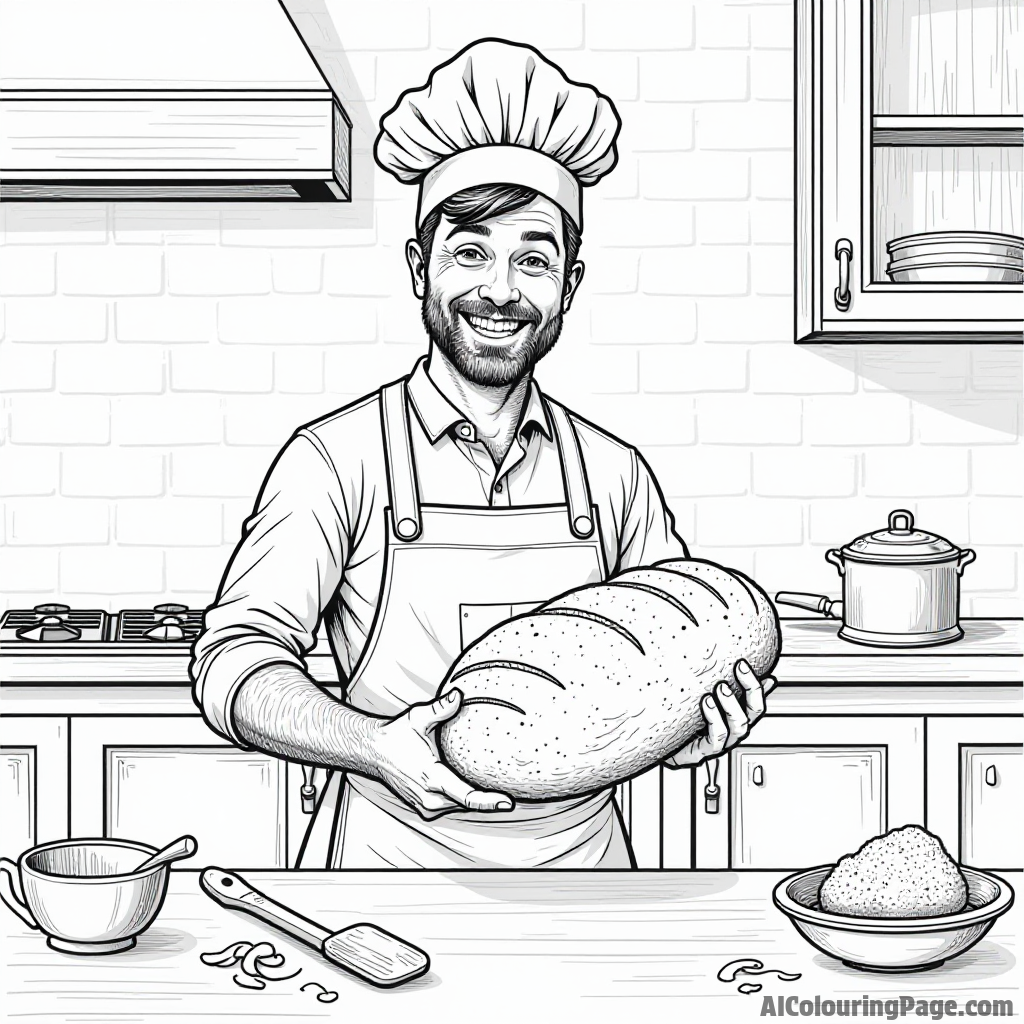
(0, 617, 1024, 686)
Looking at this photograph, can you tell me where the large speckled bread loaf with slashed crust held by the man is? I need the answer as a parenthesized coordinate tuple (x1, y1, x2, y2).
(439, 559, 779, 801)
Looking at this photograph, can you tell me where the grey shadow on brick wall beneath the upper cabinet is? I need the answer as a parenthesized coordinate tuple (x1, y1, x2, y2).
(796, 343, 1024, 437)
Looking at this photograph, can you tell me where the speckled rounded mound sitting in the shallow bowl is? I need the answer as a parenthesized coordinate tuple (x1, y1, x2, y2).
(819, 825, 968, 918)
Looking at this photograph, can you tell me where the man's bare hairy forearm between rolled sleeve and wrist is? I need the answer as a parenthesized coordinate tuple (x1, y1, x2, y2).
(231, 665, 384, 776)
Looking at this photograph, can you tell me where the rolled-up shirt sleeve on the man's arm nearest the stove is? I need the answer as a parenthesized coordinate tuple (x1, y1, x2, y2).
(190, 430, 351, 746)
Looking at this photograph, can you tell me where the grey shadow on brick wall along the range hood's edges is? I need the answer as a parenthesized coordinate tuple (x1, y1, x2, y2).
(5, 0, 378, 238)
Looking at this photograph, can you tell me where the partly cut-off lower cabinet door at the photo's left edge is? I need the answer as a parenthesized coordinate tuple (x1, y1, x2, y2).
(0, 715, 68, 859)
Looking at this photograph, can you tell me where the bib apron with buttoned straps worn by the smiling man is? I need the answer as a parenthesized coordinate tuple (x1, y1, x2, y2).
(299, 380, 635, 869)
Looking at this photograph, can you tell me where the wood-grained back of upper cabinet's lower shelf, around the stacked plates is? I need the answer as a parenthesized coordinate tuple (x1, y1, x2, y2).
(871, 145, 1024, 287)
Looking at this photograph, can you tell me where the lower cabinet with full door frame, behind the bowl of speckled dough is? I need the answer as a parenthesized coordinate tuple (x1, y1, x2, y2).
(693, 716, 925, 870)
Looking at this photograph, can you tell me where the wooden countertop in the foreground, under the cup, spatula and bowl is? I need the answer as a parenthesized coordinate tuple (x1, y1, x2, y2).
(0, 870, 1021, 1024)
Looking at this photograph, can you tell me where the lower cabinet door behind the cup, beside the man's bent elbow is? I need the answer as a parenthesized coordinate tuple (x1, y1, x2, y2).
(72, 716, 301, 868)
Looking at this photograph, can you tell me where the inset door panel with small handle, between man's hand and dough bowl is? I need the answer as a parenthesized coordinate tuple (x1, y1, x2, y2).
(731, 746, 887, 868)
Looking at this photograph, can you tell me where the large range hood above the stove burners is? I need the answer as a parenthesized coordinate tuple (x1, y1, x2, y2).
(0, 0, 351, 202)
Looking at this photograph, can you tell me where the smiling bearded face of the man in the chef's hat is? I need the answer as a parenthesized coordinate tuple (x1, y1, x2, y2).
(408, 198, 583, 386)
